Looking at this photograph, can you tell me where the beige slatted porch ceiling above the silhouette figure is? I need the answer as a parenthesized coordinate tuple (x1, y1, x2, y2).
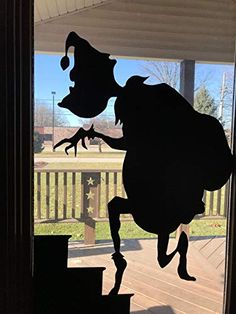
(35, 0, 236, 62)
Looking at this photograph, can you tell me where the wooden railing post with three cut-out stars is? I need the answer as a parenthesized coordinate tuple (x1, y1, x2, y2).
(81, 172, 101, 245)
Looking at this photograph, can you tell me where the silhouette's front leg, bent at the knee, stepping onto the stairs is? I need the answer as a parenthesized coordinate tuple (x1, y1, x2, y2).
(108, 196, 130, 294)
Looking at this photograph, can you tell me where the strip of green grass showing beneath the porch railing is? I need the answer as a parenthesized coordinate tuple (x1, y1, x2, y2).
(34, 219, 226, 240)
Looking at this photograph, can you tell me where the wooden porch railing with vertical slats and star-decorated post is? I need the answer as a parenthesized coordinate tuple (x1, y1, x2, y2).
(34, 169, 228, 243)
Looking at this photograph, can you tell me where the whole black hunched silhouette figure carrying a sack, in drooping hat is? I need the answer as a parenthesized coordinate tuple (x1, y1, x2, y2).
(55, 32, 232, 294)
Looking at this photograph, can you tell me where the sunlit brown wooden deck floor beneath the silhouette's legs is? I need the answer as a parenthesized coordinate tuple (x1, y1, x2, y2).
(68, 239, 224, 314)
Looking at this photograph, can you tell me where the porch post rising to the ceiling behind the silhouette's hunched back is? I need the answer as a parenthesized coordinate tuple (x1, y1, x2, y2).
(176, 60, 195, 240)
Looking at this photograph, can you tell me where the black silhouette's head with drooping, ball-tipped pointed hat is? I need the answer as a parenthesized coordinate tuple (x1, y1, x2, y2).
(58, 32, 118, 118)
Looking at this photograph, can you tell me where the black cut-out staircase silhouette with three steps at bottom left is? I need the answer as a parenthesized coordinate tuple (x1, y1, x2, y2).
(34, 235, 133, 314)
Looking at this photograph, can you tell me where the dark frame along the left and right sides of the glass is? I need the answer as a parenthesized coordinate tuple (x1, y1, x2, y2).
(0, 0, 236, 314)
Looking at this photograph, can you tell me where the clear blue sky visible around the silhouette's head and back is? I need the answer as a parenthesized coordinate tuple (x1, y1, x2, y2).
(35, 54, 233, 125)
